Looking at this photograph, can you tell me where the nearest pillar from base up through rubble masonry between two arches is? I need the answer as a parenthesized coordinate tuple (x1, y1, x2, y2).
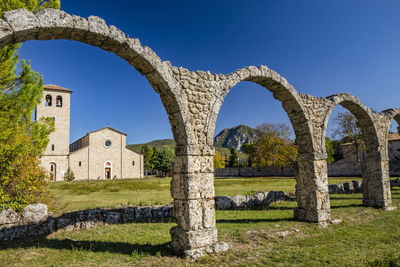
(163, 67, 228, 259)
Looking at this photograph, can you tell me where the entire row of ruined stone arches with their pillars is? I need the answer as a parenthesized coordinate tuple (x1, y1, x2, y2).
(0, 9, 400, 258)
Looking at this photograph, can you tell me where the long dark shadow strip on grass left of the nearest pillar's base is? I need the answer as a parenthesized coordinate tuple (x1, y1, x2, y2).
(0, 237, 173, 256)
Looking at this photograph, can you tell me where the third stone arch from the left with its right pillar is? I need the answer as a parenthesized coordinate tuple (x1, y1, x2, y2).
(320, 94, 392, 209)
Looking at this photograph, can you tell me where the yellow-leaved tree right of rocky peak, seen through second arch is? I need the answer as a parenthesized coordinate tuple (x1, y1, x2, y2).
(250, 123, 298, 167)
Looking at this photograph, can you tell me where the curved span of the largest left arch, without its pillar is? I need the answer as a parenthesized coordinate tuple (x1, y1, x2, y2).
(0, 9, 186, 147)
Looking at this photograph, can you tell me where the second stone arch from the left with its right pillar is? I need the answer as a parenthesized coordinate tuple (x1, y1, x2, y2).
(206, 66, 331, 225)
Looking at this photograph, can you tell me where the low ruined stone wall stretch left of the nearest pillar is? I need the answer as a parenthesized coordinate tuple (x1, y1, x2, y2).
(0, 204, 172, 241)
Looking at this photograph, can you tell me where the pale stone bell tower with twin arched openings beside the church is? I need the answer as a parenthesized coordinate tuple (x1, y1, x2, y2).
(36, 84, 72, 181)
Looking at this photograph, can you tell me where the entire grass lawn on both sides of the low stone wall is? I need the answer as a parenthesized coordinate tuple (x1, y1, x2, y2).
(0, 178, 400, 266)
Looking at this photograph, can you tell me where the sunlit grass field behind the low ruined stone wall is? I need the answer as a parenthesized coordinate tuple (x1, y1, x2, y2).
(49, 177, 360, 214)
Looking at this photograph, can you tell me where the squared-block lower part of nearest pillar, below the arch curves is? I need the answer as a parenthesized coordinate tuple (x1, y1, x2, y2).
(170, 145, 228, 258)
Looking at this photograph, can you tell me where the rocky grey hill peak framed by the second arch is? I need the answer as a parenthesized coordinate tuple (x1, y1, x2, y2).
(214, 125, 262, 151)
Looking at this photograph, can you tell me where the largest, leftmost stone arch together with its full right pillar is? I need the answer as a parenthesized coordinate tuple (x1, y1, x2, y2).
(0, 9, 227, 258)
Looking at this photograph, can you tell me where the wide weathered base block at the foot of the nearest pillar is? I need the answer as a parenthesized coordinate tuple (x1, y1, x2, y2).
(169, 226, 228, 260)
